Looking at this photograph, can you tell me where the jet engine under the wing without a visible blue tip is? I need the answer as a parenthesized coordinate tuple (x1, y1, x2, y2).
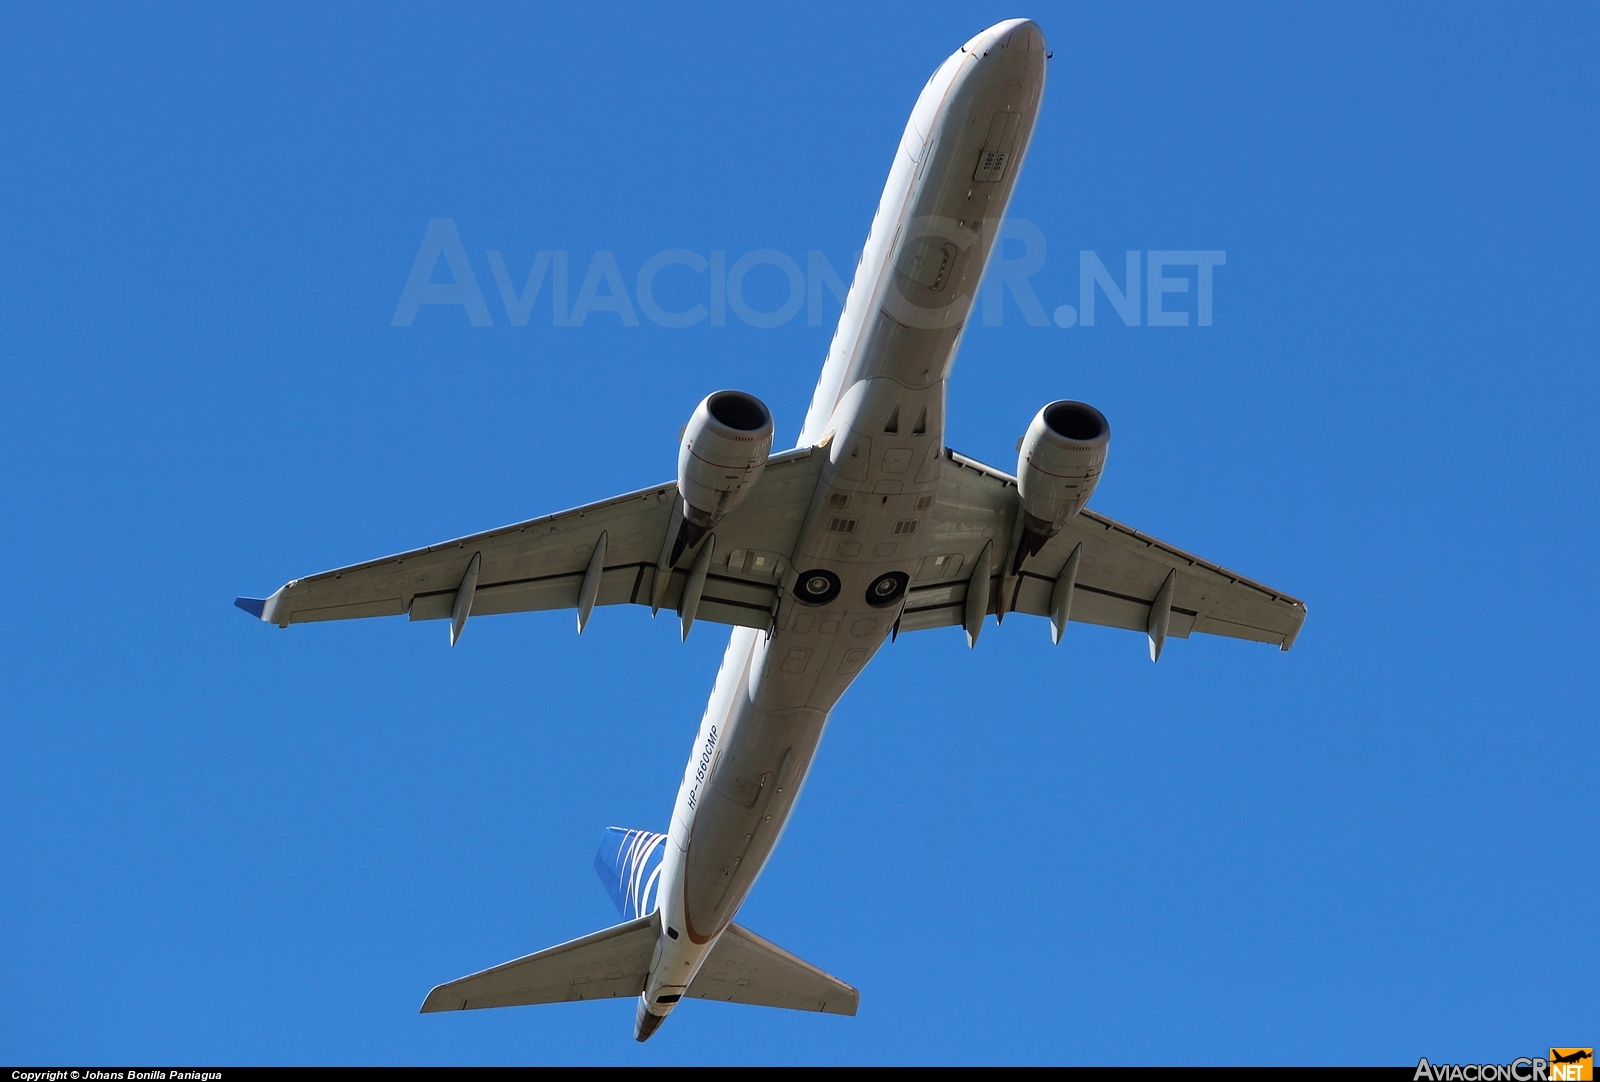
(1013, 402, 1110, 573)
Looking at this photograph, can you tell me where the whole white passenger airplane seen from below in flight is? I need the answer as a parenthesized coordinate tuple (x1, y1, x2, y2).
(235, 19, 1306, 1040)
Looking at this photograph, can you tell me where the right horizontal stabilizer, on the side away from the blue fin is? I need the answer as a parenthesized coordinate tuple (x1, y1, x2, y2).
(688, 924, 861, 1015)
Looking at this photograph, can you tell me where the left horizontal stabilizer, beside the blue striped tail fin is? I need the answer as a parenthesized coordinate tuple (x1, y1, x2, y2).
(422, 916, 659, 1015)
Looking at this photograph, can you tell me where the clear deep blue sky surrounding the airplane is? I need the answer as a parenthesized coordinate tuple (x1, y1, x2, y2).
(0, 3, 1600, 1064)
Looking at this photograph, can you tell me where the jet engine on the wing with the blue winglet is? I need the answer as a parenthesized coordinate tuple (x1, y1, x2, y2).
(672, 391, 773, 563)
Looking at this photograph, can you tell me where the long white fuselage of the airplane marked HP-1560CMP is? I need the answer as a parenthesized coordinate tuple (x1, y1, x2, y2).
(643, 19, 1046, 1015)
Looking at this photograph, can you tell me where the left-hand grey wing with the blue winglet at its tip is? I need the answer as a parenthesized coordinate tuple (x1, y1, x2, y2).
(235, 448, 826, 629)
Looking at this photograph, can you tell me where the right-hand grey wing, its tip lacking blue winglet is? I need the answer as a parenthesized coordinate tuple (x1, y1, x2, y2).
(898, 450, 1306, 655)
